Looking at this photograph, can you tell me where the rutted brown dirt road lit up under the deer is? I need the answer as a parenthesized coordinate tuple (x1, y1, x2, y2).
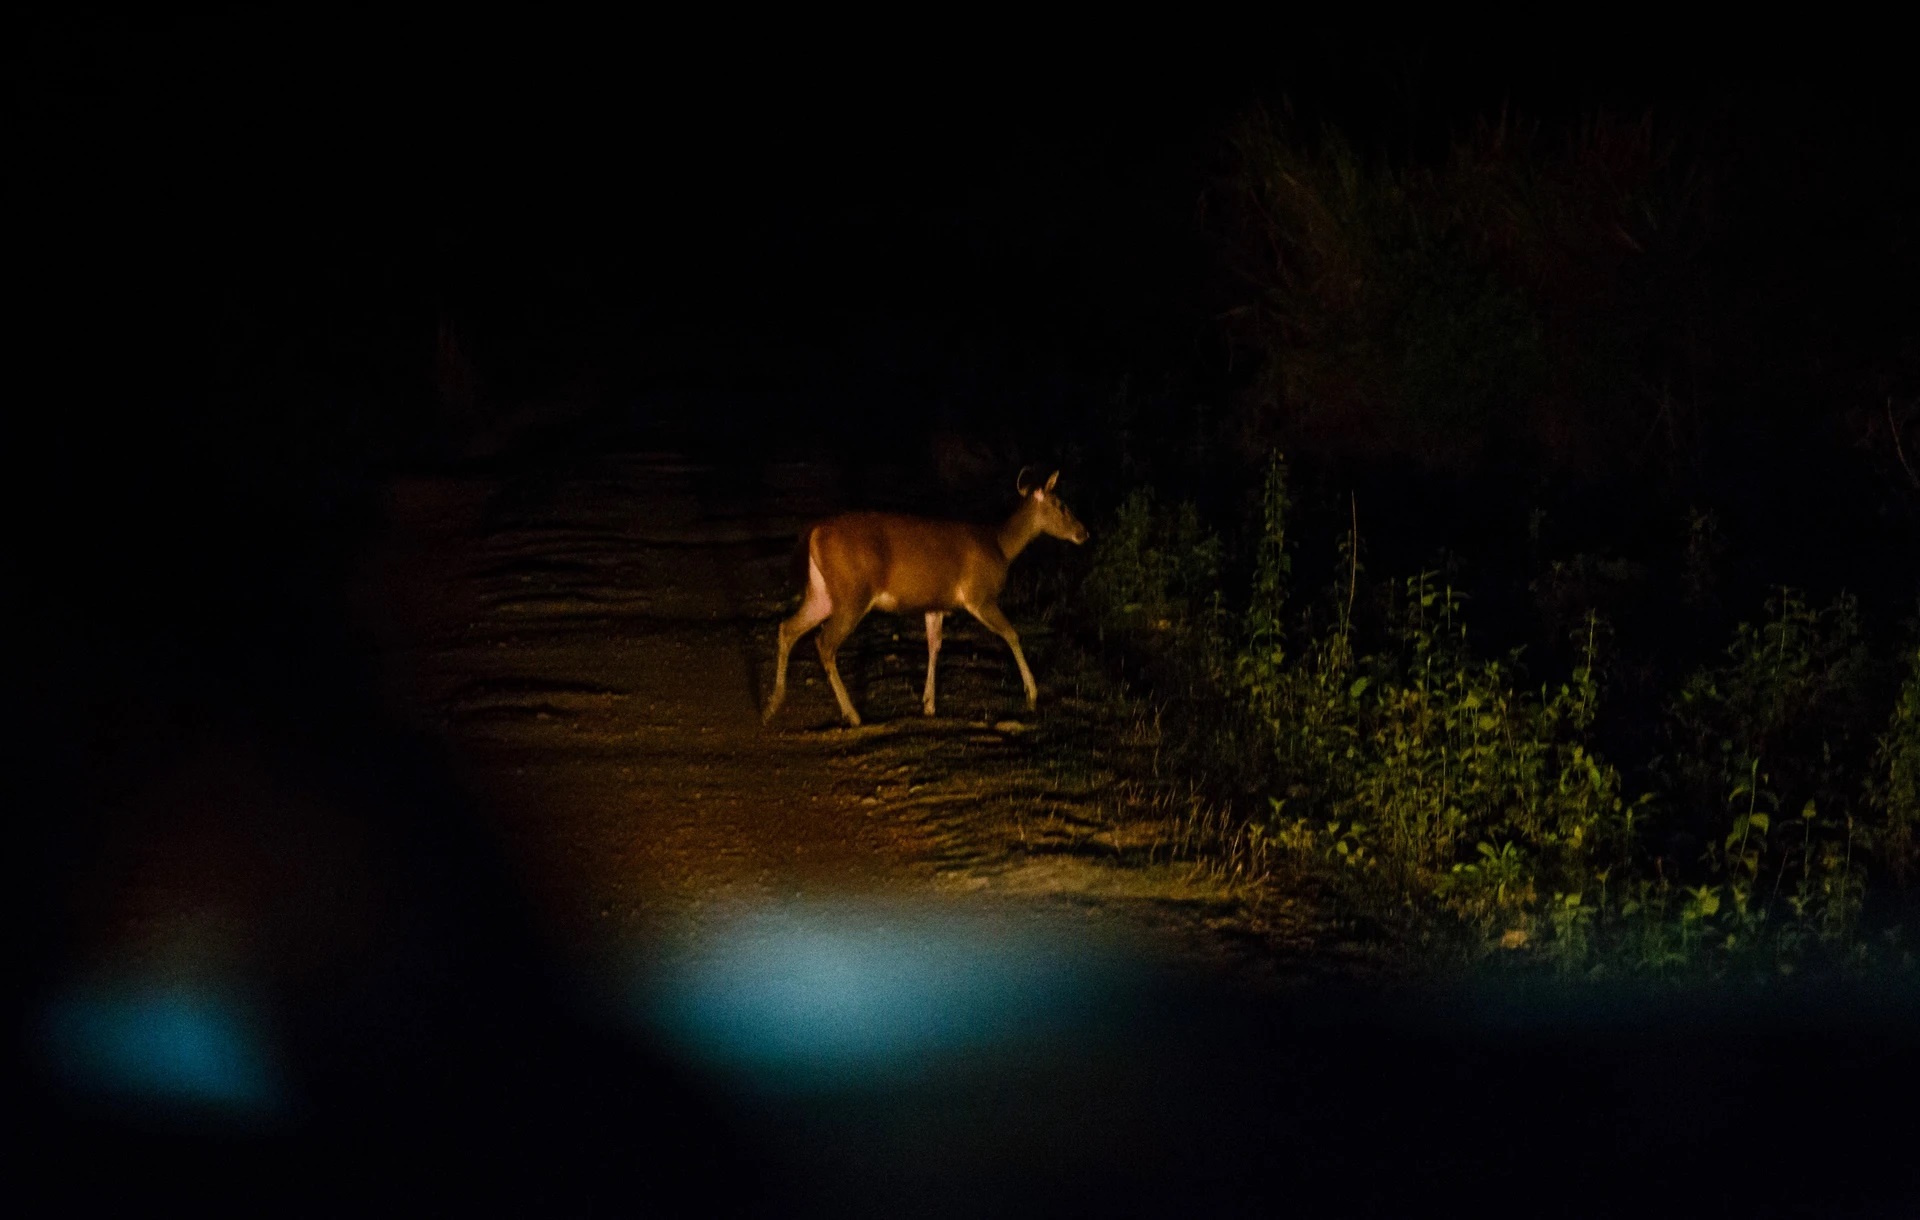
(369, 453, 1305, 972)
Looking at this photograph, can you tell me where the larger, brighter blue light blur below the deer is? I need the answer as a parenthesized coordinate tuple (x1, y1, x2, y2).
(641, 905, 1119, 1087)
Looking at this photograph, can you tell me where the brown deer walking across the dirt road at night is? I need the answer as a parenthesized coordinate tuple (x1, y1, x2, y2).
(760, 471, 1087, 728)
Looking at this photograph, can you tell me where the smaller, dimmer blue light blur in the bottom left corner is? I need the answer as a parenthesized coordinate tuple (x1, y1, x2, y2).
(42, 984, 286, 1120)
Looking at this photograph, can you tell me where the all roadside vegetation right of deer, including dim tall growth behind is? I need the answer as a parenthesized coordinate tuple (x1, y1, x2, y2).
(1064, 102, 1920, 978)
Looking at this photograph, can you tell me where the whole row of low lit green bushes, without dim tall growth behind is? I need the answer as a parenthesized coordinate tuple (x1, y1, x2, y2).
(1087, 457, 1920, 976)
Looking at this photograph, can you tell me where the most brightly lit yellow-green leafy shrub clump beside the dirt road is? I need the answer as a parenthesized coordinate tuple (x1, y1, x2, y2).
(1236, 459, 1644, 960)
